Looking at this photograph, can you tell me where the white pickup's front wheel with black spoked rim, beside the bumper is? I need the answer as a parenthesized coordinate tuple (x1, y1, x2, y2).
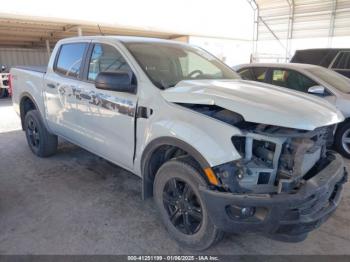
(153, 160, 223, 250)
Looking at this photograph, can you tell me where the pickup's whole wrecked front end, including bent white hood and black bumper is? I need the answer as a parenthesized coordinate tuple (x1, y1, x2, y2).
(167, 80, 347, 241)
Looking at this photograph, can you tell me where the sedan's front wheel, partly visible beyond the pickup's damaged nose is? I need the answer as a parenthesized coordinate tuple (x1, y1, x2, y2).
(334, 121, 350, 158)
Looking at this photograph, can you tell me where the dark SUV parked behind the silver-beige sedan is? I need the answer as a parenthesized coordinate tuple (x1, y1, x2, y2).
(290, 48, 350, 78)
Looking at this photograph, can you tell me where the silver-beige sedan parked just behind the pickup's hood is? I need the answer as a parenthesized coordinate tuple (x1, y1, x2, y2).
(235, 63, 350, 158)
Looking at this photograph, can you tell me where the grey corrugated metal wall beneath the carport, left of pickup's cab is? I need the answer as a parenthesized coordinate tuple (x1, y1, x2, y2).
(0, 48, 49, 67)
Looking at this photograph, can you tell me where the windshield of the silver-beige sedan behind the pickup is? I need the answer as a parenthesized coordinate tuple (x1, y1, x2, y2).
(307, 67, 350, 93)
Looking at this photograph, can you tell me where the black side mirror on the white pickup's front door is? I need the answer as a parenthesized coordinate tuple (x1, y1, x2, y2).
(95, 71, 136, 94)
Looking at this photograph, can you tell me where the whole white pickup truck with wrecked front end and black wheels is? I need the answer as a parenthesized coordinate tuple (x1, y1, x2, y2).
(11, 36, 347, 250)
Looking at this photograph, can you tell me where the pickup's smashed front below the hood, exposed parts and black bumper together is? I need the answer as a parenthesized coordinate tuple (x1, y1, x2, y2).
(187, 104, 347, 241)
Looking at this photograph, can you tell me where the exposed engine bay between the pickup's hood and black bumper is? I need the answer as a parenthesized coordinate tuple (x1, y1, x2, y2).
(182, 104, 335, 193)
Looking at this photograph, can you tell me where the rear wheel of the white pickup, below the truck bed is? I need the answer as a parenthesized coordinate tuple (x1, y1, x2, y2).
(24, 110, 57, 157)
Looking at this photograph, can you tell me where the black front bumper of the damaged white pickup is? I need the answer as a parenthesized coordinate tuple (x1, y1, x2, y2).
(200, 153, 347, 242)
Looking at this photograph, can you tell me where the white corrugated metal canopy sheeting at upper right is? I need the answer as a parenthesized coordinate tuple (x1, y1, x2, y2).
(256, 0, 350, 40)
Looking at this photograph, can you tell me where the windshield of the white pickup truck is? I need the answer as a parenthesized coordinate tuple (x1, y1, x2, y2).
(125, 42, 240, 89)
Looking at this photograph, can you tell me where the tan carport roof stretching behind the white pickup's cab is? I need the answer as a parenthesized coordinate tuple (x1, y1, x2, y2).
(0, 16, 186, 48)
